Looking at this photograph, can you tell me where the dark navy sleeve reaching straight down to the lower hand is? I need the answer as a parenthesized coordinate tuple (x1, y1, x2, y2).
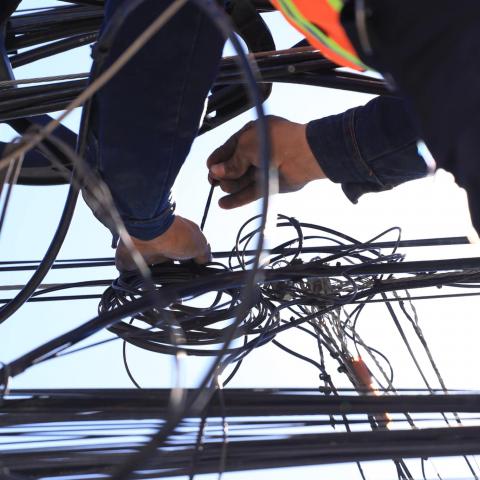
(90, 0, 224, 240)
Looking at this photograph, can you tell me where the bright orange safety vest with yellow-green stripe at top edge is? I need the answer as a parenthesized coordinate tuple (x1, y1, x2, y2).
(270, 0, 366, 70)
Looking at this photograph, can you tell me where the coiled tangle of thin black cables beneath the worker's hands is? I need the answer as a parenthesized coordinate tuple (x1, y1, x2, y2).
(99, 215, 403, 361)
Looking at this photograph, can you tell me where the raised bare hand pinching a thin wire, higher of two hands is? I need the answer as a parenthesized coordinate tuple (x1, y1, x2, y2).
(207, 116, 326, 209)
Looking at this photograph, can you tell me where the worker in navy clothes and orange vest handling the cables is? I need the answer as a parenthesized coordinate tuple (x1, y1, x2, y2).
(83, 0, 480, 270)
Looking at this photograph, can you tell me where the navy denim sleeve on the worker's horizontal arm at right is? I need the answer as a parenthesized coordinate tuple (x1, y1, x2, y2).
(307, 97, 428, 203)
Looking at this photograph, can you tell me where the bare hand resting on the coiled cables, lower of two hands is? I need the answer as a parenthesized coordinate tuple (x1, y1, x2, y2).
(115, 215, 211, 272)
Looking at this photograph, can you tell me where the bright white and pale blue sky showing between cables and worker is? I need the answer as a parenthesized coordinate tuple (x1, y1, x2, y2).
(0, 0, 480, 479)
